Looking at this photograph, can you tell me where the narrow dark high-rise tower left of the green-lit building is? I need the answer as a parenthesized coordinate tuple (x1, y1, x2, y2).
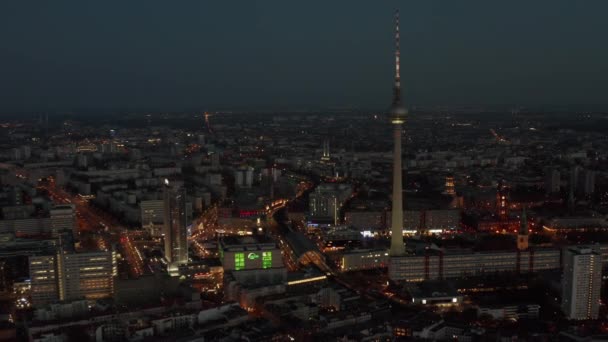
(163, 179, 188, 271)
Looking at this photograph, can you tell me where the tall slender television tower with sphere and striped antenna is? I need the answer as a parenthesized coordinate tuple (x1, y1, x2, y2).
(389, 10, 407, 256)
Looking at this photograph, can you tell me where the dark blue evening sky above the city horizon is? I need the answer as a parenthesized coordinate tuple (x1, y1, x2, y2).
(0, 0, 608, 111)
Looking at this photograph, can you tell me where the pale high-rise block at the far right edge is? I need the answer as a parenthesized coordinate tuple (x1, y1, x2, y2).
(562, 246, 602, 320)
